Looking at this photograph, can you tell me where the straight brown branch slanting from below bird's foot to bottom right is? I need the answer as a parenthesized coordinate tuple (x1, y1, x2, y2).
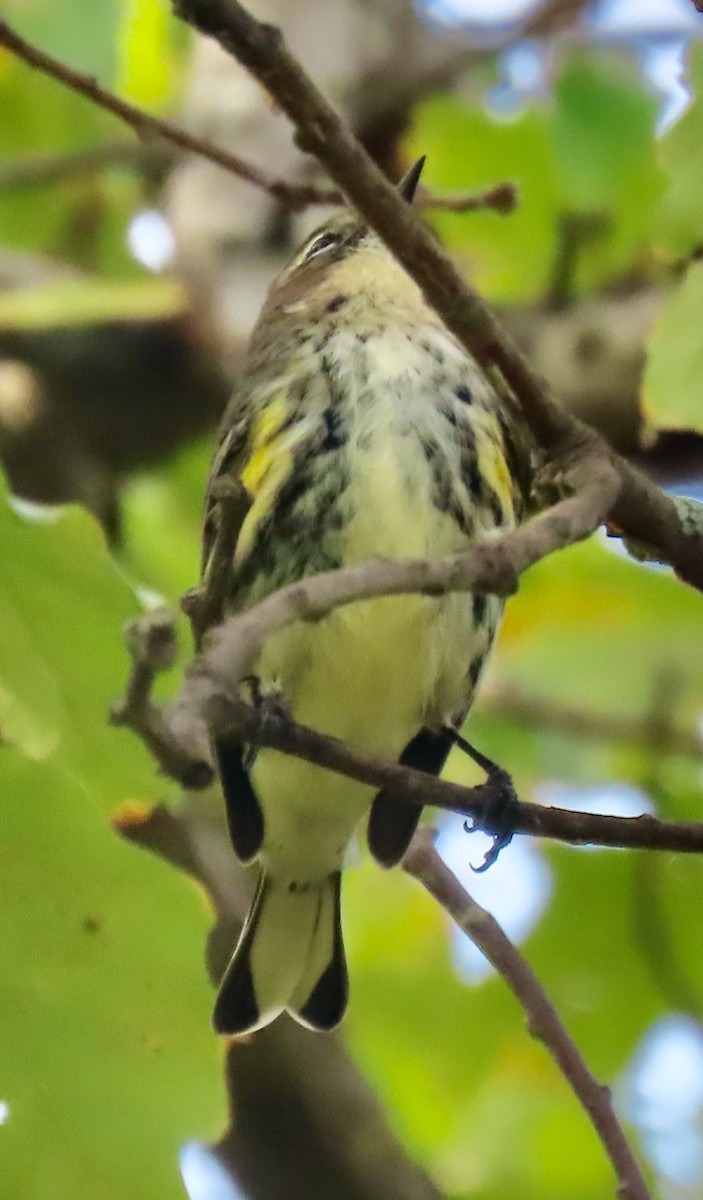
(403, 829, 651, 1200)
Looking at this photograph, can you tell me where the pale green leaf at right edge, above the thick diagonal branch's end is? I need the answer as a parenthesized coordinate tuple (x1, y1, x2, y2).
(642, 258, 703, 433)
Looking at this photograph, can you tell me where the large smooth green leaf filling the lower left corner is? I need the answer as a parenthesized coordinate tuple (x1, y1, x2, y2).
(0, 748, 224, 1200)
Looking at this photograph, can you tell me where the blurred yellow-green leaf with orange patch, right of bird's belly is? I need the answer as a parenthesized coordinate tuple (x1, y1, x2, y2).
(500, 538, 703, 729)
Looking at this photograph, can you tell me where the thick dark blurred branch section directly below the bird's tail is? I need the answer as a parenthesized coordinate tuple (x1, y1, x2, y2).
(220, 1020, 443, 1200)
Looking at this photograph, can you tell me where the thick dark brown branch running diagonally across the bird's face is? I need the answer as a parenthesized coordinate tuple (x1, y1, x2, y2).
(169, 0, 703, 589)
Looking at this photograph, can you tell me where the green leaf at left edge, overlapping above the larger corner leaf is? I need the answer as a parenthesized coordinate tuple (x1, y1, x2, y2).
(0, 472, 169, 810)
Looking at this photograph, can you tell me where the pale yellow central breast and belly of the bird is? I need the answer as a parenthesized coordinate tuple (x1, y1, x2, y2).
(249, 329, 494, 757)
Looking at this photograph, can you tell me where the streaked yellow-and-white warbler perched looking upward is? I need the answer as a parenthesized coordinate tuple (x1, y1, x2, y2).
(204, 160, 523, 1033)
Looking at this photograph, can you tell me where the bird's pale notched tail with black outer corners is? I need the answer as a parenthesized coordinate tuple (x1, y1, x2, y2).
(214, 871, 348, 1033)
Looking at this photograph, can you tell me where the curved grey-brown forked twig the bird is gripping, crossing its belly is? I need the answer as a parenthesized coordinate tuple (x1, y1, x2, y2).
(107, 461, 703, 852)
